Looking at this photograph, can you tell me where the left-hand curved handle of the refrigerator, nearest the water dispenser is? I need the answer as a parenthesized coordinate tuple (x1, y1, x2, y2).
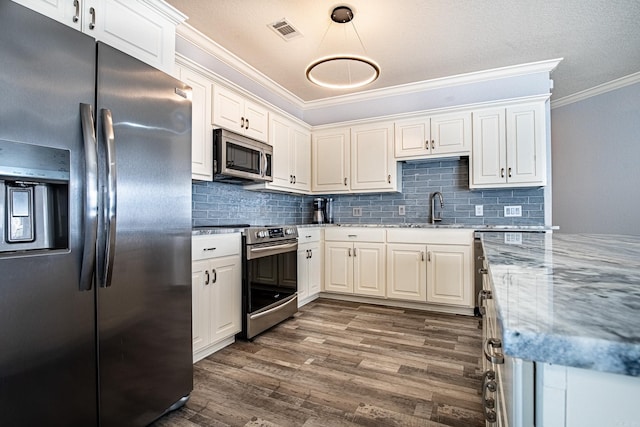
(80, 104, 98, 291)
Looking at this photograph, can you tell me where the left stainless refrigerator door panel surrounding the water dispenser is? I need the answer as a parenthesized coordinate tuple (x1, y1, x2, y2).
(0, 1, 97, 426)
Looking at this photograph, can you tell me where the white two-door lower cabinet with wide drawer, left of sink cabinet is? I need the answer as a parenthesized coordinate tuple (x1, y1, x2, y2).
(323, 227, 386, 297)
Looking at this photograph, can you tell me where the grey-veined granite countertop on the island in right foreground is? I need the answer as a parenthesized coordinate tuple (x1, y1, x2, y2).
(482, 233, 640, 376)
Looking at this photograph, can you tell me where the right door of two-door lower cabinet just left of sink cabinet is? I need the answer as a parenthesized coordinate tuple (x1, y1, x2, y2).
(353, 243, 386, 297)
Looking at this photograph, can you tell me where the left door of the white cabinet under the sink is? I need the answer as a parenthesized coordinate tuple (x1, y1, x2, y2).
(387, 244, 427, 302)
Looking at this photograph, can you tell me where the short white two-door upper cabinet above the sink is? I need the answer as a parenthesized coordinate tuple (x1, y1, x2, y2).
(395, 112, 471, 159)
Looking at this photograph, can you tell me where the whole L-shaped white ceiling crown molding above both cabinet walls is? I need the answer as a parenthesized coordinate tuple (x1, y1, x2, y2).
(176, 23, 563, 111)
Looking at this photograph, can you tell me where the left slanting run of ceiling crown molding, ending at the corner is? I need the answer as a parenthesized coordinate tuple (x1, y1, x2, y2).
(176, 22, 304, 109)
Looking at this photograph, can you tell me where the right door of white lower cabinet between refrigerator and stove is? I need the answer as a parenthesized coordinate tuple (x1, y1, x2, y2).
(209, 256, 242, 343)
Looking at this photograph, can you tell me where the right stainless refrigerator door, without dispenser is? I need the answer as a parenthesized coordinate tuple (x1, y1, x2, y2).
(97, 43, 192, 427)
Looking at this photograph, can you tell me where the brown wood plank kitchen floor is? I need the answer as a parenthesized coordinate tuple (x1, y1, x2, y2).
(153, 299, 484, 427)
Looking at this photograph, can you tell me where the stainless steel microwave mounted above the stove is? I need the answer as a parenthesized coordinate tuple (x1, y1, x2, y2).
(213, 129, 273, 183)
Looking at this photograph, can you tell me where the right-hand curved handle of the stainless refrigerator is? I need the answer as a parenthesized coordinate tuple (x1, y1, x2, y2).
(100, 108, 118, 288)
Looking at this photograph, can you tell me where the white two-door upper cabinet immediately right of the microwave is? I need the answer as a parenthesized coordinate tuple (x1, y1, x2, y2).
(267, 114, 311, 193)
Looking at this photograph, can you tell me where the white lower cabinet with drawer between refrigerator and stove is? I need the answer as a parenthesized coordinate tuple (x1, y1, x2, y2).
(191, 233, 242, 362)
